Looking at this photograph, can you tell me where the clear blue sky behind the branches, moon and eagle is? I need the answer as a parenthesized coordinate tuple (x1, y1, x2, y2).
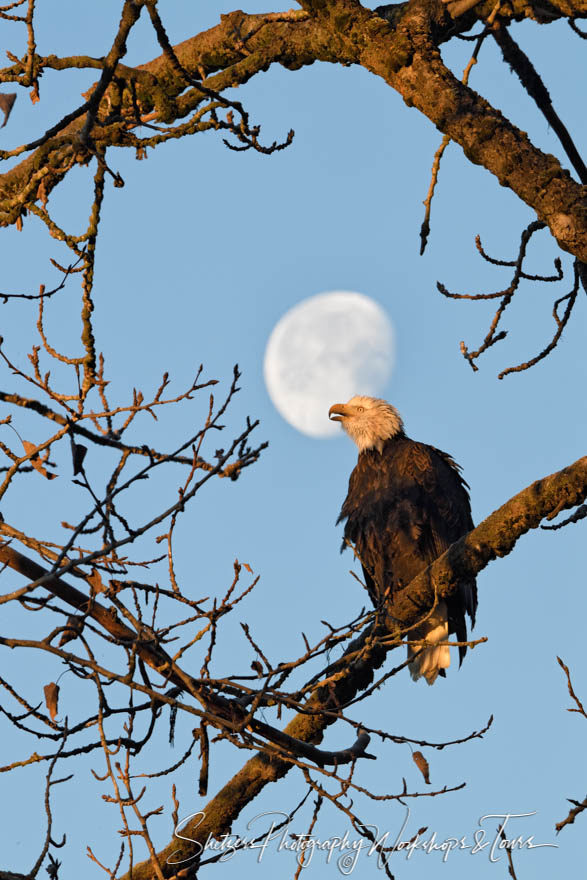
(0, 0, 587, 880)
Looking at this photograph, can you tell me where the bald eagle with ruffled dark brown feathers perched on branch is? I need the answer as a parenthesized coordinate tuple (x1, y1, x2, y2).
(328, 396, 477, 684)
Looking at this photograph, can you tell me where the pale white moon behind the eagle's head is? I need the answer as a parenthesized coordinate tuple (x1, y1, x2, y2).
(263, 290, 394, 437)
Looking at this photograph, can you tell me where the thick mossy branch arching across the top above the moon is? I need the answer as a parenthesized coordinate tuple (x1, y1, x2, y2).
(0, 0, 587, 262)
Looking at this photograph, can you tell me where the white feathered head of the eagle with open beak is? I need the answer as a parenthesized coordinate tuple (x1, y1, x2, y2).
(328, 394, 404, 452)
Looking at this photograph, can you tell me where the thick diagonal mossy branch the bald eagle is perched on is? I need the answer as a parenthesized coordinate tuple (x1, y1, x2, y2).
(119, 456, 587, 880)
